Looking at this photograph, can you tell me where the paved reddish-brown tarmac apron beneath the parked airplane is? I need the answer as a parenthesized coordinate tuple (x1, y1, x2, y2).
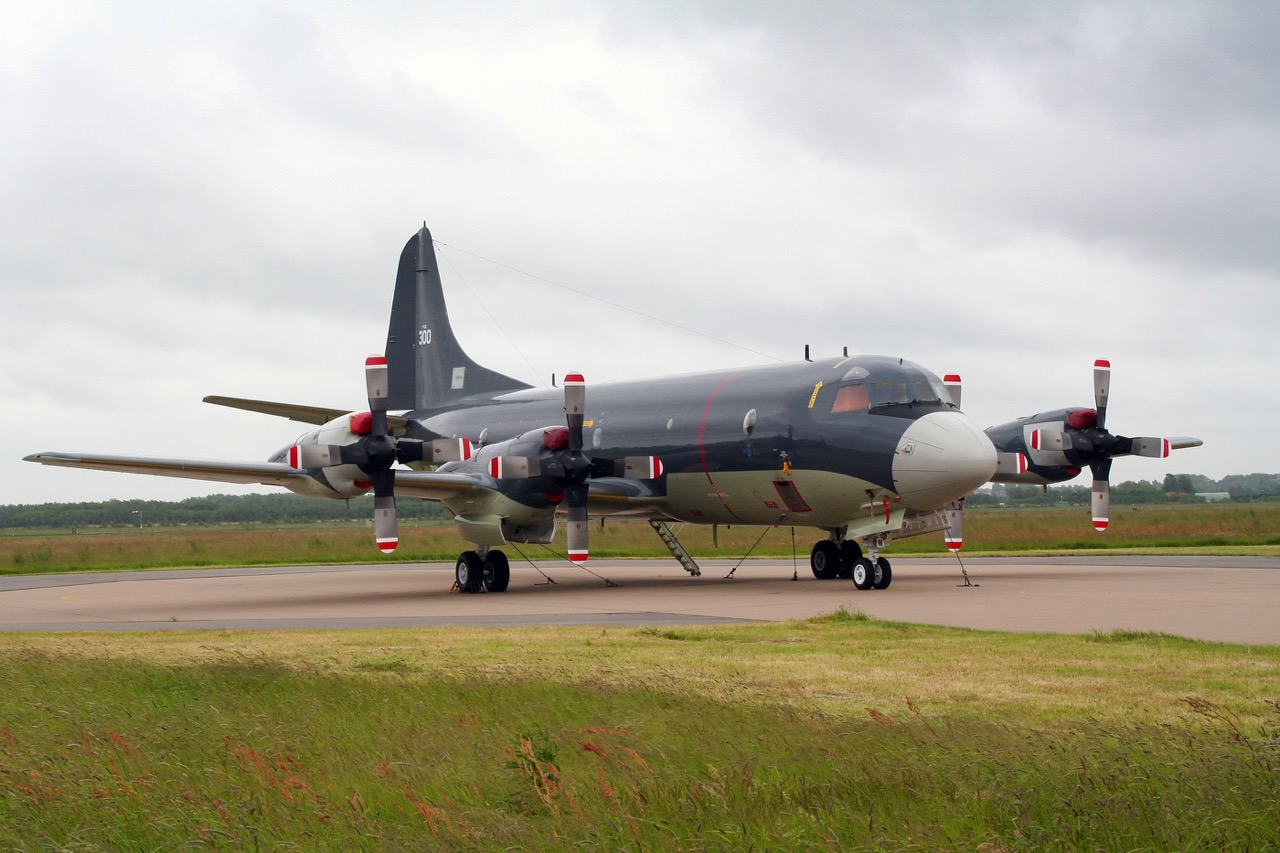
(0, 557, 1280, 646)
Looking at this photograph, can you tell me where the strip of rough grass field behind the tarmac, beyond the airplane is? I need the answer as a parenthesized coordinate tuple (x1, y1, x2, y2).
(0, 503, 1280, 574)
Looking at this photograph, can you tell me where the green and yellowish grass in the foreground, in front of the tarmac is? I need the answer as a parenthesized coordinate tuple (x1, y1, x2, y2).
(0, 612, 1280, 850)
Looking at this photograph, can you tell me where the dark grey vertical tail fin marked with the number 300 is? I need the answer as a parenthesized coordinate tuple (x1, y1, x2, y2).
(387, 225, 530, 410)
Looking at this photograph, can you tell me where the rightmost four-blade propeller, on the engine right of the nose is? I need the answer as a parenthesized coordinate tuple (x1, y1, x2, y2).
(1030, 359, 1202, 532)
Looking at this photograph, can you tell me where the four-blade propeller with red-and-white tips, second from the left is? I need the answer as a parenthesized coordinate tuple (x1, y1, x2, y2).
(489, 373, 662, 564)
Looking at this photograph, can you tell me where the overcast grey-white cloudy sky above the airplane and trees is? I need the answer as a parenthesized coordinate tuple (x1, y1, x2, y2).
(0, 0, 1280, 503)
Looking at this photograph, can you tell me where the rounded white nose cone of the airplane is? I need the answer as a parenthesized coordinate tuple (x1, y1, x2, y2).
(893, 411, 996, 510)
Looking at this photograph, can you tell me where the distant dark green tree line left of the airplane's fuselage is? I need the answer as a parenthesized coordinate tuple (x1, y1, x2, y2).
(0, 493, 444, 529)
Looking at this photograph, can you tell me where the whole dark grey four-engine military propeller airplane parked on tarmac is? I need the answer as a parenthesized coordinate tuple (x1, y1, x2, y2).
(26, 225, 1201, 593)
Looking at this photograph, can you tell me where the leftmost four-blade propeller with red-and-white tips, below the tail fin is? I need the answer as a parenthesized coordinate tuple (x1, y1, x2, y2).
(289, 355, 472, 553)
